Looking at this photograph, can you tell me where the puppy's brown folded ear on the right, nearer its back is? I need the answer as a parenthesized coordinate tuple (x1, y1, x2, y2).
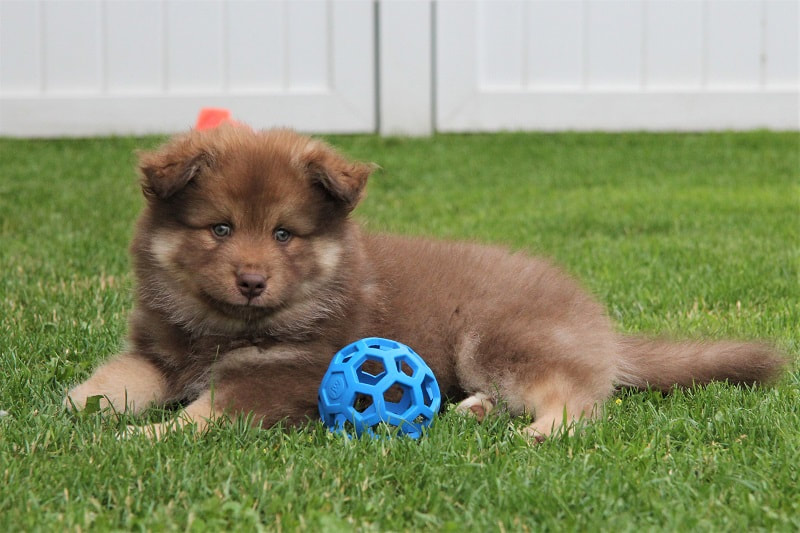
(303, 141, 378, 212)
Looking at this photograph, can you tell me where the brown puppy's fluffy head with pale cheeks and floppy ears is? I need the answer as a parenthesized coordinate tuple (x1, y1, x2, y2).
(133, 126, 373, 331)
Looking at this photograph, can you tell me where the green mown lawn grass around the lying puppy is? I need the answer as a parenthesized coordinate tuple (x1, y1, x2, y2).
(0, 132, 800, 531)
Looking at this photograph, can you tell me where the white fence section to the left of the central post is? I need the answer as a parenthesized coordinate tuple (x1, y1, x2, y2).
(0, 0, 376, 136)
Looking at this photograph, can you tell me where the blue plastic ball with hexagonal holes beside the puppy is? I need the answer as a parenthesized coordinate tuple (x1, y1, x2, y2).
(319, 337, 442, 439)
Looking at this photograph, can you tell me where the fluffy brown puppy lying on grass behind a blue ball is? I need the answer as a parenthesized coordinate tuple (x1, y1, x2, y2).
(67, 126, 785, 439)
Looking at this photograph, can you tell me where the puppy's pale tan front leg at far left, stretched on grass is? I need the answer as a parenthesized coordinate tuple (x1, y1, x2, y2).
(64, 353, 167, 414)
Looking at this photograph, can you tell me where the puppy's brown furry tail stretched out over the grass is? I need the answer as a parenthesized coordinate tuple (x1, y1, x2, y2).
(617, 337, 788, 391)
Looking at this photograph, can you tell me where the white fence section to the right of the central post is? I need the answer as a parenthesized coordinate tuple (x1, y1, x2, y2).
(435, 0, 800, 131)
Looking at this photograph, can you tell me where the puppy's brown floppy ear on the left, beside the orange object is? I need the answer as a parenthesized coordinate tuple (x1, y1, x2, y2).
(139, 137, 211, 200)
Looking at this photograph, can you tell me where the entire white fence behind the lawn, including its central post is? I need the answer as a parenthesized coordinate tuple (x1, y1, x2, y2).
(0, 0, 800, 136)
